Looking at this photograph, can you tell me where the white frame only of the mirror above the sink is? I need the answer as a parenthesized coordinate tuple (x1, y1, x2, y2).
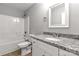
(49, 3, 69, 28)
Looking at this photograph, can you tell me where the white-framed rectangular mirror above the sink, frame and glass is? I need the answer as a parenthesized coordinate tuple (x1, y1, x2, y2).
(49, 3, 69, 28)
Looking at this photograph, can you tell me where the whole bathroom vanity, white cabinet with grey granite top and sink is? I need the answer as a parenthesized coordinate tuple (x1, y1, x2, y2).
(30, 34, 79, 56)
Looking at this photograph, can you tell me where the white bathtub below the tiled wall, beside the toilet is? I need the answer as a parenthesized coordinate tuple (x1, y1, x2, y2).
(0, 40, 24, 56)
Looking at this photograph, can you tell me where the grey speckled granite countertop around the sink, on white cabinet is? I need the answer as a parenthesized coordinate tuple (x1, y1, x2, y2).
(30, 34, 79, 55)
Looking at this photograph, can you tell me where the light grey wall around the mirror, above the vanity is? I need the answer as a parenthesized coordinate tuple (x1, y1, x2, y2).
(26, 3, 79, 34)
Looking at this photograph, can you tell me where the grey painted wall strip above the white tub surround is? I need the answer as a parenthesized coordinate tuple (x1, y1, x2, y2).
(0, 5, 24, 17)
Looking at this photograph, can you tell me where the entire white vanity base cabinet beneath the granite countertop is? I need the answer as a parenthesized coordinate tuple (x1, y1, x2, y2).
(32, 38, 77, 56)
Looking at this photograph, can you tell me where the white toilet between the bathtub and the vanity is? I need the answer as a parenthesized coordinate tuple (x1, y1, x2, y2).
(18, 41, 31, 56)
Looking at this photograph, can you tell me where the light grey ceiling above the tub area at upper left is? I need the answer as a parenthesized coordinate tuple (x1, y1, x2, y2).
(0, 3, 34, 11)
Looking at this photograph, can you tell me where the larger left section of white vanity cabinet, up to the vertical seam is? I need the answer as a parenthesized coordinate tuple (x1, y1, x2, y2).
(32, 38, 58, 56)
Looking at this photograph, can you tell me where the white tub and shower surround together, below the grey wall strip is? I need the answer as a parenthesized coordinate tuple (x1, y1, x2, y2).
(0, 15, 24, 55)
